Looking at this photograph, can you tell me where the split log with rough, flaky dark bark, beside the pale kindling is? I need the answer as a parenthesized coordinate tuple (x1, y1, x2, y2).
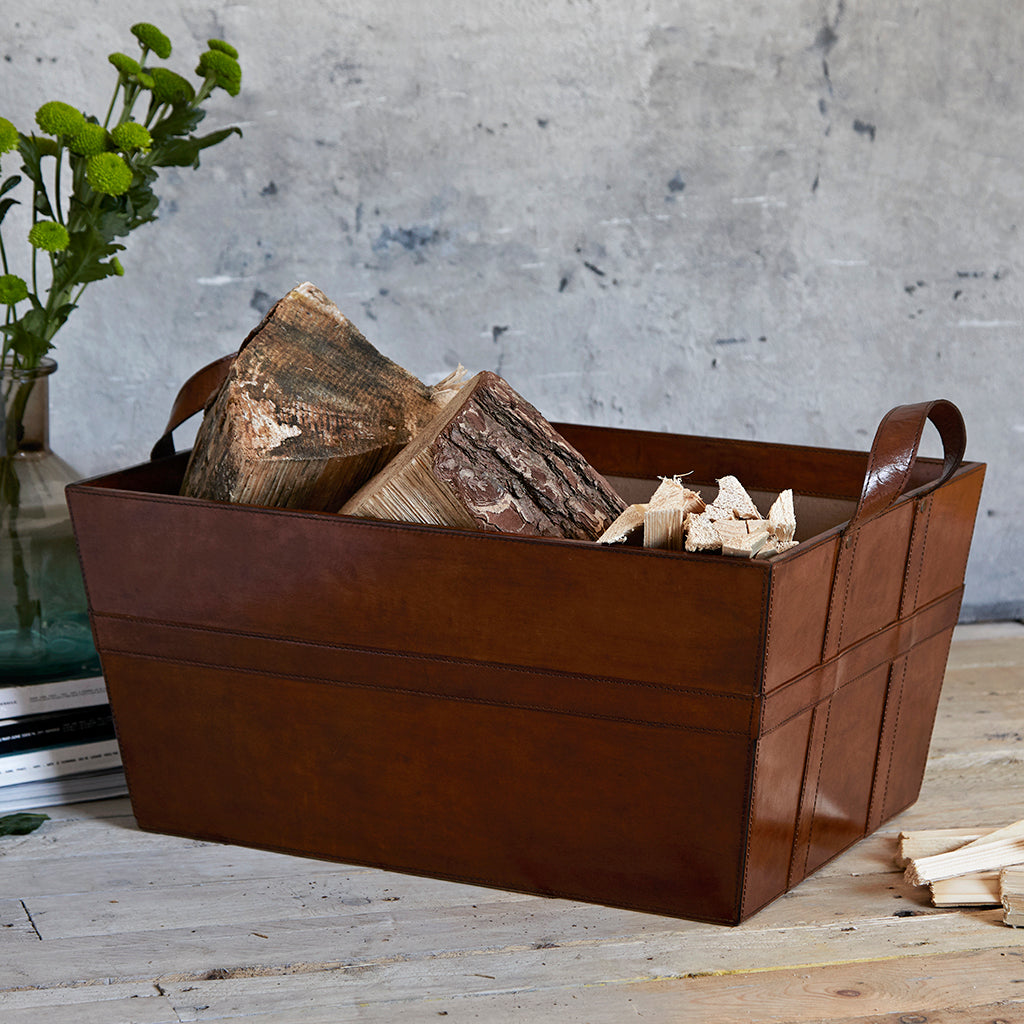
(341, 371, 626, 541)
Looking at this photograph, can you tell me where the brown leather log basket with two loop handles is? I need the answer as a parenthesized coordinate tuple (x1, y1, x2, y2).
(68, 367, 985, 924)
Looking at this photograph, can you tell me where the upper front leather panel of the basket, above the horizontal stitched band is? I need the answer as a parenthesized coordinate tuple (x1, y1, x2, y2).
(69, 486, 769, 694)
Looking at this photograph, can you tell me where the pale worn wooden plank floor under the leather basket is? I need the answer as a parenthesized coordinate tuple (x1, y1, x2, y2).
(0, 624, 1024, 1024)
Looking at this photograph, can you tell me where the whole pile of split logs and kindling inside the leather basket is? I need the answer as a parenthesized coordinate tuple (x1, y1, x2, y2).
(181, 283, 797, 558)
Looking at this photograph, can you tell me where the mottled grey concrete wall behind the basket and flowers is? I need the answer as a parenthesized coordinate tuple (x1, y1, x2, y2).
(0, 0, 1024, 617)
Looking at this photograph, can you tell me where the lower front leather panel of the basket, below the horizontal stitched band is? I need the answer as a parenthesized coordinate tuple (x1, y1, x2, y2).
(104, 653, 750, 922)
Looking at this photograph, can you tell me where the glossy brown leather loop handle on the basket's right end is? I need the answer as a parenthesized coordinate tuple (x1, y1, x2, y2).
(848, 398, 967, 528)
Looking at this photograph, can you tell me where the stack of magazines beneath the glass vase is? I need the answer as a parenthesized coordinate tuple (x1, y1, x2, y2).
(0, 676, 128, 814)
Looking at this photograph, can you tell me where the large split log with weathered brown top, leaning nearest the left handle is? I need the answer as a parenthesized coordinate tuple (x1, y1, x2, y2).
(181, 283, 454, 512)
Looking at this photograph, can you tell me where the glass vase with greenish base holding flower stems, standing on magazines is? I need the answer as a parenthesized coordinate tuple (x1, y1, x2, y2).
(0, 358, 100, 685)
